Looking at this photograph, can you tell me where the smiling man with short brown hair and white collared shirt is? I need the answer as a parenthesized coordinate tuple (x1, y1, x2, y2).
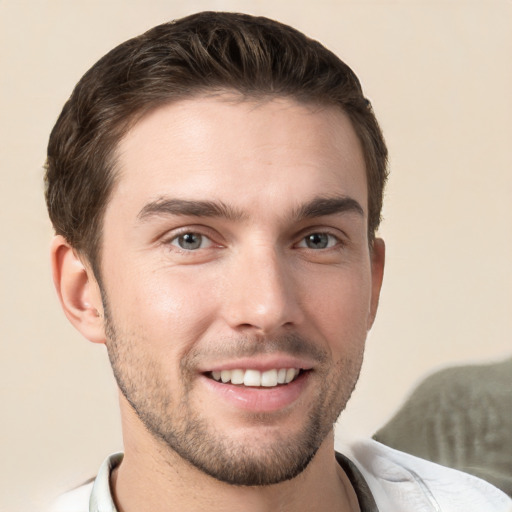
(46, 13, 510, 512)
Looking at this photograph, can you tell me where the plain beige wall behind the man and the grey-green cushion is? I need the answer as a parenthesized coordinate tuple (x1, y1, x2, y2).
(0, 0, 512, 511)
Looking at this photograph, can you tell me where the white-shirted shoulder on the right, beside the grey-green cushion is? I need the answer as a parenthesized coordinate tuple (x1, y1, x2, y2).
(345, 440, 512, 512)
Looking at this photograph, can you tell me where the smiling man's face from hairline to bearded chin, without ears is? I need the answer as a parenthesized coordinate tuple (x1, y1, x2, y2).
(101, 95, 380, 485)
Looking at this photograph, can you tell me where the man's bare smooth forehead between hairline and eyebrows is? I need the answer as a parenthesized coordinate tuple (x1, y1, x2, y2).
(107, 94, 367, 220)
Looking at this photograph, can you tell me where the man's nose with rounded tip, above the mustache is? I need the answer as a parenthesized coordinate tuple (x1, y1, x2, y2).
(223, 247, 303, 336)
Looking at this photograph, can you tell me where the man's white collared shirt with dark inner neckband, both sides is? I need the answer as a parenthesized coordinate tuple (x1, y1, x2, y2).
(52, 440, 512, 512)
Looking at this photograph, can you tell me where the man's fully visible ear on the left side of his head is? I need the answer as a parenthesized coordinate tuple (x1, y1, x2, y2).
(51, 235, 105, 343)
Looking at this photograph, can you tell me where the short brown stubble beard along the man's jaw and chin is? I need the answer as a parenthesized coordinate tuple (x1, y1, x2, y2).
(104, 303, 364, 486)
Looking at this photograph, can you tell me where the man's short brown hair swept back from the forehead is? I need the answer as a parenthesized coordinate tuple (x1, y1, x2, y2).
(45, 12, 387, 277)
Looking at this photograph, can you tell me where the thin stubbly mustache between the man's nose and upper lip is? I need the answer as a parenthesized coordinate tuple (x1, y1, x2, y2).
(182, 333, 328, 367)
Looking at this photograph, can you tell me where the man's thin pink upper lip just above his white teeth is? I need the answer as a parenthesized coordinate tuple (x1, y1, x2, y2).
(199, 354, 313, 373)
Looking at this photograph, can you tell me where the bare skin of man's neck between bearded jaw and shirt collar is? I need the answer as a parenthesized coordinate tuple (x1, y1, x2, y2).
(110, 398, 360, 512)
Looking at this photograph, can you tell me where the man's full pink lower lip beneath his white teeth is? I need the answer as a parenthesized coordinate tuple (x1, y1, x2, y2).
(202, 372, 310, 412)
